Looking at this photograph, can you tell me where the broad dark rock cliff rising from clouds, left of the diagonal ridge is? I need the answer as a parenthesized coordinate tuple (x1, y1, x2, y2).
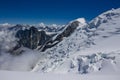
(16, 26, 53, 49)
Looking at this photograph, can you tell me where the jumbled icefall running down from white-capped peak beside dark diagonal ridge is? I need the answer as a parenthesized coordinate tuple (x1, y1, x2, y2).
(33, 18, 92, 72)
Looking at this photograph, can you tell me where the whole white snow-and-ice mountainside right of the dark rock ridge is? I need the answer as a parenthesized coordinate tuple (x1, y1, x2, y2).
(32, 9, 120, 74)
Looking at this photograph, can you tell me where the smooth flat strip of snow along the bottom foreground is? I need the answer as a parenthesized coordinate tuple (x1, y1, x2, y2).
(0, 71, 120, 80)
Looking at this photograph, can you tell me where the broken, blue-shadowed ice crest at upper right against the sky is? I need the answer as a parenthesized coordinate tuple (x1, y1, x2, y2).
(89, 8, 120, 28)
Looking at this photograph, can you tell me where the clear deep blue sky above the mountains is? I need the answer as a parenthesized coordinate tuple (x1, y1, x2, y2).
(0, 0, 120, 24)
